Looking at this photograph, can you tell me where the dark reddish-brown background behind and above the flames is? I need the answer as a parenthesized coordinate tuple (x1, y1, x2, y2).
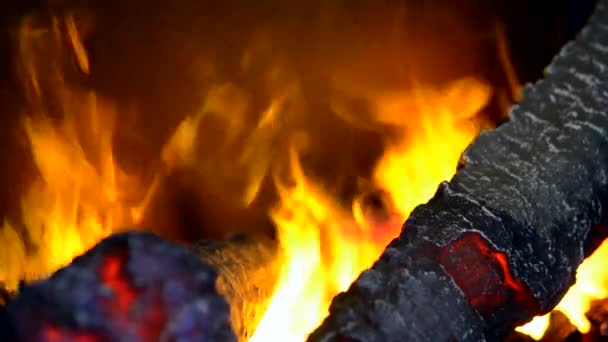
(0, 0, 593, 240)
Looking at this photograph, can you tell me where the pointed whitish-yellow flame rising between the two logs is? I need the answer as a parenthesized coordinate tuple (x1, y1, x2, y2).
(250, 152, 388, 341)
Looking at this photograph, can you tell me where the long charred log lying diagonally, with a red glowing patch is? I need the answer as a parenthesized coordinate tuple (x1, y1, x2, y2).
(309, 0, 608, 341)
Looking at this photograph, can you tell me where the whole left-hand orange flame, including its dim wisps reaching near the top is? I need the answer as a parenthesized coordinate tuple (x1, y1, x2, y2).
(0, 16, 142, 289)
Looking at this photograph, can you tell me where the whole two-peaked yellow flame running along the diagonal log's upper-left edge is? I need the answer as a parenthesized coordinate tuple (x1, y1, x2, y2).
(250, 78, 490, 342)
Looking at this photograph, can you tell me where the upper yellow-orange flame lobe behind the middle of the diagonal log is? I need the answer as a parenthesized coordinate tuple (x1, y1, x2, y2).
(375, 78, 491, 217)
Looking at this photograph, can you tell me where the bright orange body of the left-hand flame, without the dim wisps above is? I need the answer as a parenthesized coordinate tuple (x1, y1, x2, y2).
(0, 97, 134, 288)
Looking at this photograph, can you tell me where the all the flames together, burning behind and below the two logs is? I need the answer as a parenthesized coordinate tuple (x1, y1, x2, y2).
(7, 8, 608, 342)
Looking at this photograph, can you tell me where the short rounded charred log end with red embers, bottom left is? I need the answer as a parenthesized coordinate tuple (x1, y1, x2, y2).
(0, 233, 236, 341)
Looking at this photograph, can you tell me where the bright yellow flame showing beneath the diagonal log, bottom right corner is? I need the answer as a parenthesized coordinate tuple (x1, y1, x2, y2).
(516, 240, 608, 340)
